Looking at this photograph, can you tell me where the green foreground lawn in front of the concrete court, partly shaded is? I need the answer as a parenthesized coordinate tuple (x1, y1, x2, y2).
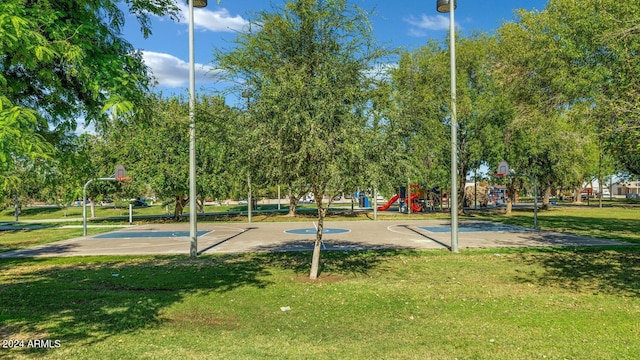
(0, 248, 640, 359)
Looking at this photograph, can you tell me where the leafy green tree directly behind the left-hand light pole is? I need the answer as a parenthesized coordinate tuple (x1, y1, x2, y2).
(99, 95, 237, 219)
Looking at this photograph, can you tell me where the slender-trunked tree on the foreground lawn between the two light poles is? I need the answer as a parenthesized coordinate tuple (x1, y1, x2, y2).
(215, 0, 384, 279)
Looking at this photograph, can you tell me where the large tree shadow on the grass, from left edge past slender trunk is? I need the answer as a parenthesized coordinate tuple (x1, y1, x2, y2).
(0, 251, 397, 358)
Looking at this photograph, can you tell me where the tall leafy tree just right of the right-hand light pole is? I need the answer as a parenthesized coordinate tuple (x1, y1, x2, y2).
(495, 3, 607, 207)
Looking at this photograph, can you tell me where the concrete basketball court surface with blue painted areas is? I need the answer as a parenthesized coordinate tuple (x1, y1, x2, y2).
(0, 220, 628, 258)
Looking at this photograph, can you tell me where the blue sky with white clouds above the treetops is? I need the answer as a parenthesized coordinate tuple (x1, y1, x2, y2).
(123, 0, 547, 94)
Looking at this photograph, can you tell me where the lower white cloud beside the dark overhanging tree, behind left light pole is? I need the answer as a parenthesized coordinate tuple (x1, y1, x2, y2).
(142, 51, 216, 87)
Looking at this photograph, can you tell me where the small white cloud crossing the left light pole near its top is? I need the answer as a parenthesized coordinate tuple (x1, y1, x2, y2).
(178, 2, 249, 32)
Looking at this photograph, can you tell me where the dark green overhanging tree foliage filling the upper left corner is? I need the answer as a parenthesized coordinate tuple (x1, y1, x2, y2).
(0, 0, 179, 200)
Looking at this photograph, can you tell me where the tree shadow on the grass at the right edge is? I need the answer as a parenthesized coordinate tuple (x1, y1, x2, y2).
(517, 246, 640, 297)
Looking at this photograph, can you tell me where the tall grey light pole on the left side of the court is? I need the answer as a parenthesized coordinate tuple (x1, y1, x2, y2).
(187, 0, 207, 259)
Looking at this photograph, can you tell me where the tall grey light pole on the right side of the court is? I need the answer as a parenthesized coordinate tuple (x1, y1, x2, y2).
(436, 0, 458, 253)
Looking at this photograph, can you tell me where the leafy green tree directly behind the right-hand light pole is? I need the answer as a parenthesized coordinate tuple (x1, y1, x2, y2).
(394, 35, 510, 211)
